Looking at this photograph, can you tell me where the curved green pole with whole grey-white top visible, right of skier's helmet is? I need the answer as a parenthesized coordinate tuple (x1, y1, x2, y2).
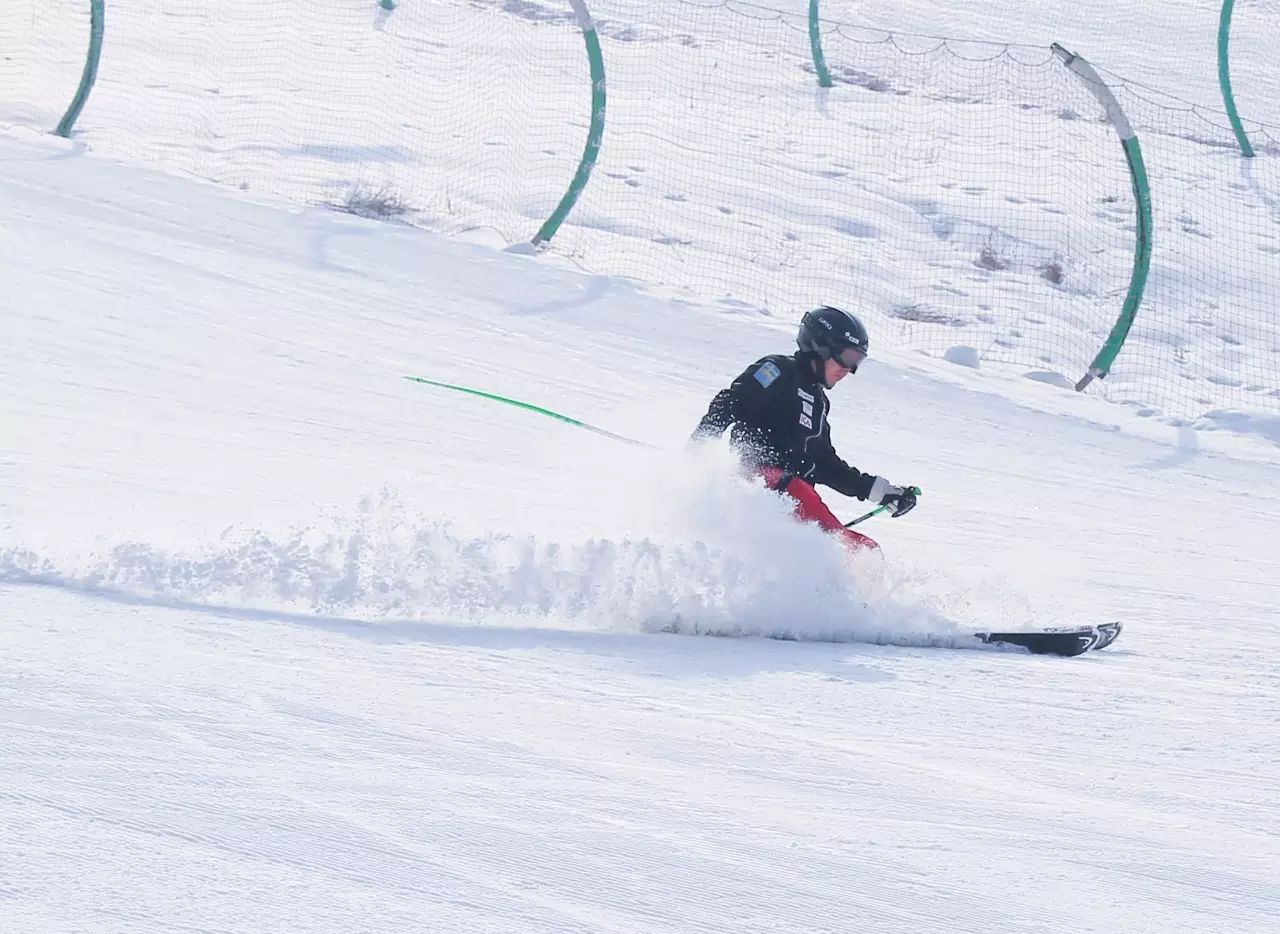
(1052, 42, 1152, 392)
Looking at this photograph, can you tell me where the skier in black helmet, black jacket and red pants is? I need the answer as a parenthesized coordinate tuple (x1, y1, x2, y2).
(690, 306, 915, 550)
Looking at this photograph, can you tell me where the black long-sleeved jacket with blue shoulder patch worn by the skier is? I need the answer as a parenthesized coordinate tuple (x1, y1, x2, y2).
(692, 353, 876, 499)
